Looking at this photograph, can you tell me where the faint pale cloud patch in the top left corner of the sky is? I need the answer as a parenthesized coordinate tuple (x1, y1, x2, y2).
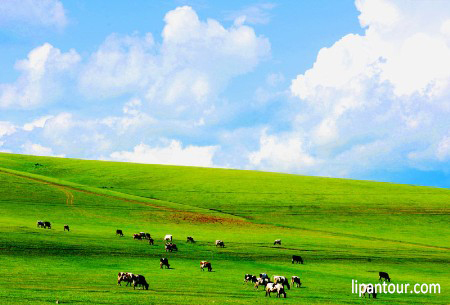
(0, 0, 67, 28)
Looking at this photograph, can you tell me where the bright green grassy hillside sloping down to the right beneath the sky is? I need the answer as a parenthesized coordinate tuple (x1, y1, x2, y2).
(0, 153, 450, 304)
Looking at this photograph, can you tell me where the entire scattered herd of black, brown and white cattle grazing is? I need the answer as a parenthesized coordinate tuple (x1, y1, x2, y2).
(37, 220, 391, 298)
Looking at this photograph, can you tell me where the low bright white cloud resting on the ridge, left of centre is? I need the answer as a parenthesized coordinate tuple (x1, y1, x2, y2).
(110, 140, 217, 167)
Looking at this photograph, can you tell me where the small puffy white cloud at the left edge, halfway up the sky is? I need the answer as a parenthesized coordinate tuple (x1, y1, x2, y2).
(0, 43, 80, 109)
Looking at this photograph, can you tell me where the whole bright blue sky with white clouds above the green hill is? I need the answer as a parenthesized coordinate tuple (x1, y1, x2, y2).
(0, 0, 450, 188)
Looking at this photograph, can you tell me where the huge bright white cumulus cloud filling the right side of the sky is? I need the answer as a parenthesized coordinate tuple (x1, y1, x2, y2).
(253, 0, 450, 175)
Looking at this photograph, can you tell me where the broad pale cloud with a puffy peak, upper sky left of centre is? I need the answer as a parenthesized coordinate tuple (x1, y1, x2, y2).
(79, 6, 270, 116)
